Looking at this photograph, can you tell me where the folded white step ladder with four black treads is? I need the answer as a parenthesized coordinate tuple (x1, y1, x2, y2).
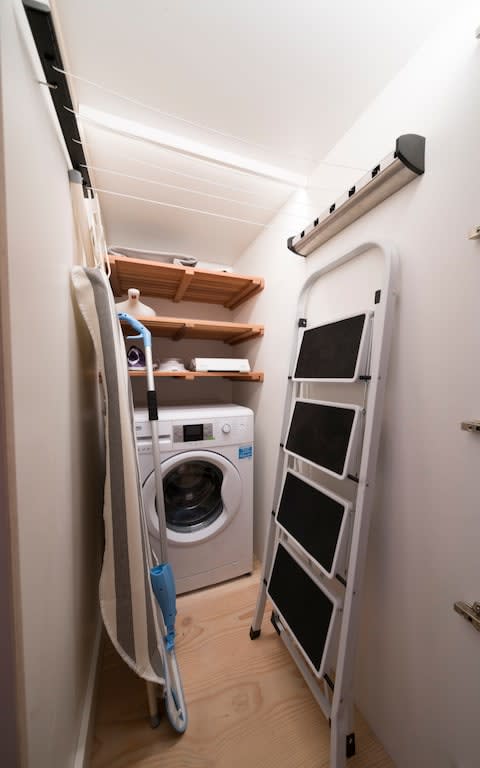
(250, 242, 397, 768)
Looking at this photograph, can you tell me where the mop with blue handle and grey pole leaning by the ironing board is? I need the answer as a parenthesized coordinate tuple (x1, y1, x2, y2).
(118, 312, 187, 733)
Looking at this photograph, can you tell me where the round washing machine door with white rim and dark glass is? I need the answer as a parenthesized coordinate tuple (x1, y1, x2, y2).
(143, 450, 242, 546)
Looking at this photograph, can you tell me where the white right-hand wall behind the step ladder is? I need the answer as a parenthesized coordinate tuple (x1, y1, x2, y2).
(234, 3, 480, 768)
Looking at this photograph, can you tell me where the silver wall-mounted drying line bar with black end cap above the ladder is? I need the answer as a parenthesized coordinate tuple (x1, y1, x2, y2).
(287, 133, 425, 256)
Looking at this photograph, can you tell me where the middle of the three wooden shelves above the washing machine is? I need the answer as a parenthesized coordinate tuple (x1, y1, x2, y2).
(122, 317, 263, 345)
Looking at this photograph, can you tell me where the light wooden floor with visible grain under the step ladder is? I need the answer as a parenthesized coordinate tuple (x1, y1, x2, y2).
(91, 575, 394, 768)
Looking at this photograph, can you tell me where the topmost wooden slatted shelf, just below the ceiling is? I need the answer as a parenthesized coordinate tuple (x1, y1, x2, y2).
(109, 256, 264, 309)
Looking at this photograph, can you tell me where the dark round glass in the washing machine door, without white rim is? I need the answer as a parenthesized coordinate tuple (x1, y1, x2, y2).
(163, 459, 223, 533)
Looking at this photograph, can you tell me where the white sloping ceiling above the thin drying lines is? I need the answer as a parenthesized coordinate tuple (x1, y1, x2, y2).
(53, 0, 458, 263)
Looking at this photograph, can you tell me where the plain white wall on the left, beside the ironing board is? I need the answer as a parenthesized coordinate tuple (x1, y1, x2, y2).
(0, 0, 101, 768)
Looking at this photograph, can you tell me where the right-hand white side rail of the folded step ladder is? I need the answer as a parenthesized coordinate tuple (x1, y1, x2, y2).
(330, 244, 397, 768)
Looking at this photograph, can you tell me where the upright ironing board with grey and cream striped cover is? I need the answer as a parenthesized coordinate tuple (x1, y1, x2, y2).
(72, 266, 165, 688)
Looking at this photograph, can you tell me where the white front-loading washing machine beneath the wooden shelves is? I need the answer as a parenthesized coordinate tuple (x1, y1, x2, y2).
(135, 405, 253, 594)
